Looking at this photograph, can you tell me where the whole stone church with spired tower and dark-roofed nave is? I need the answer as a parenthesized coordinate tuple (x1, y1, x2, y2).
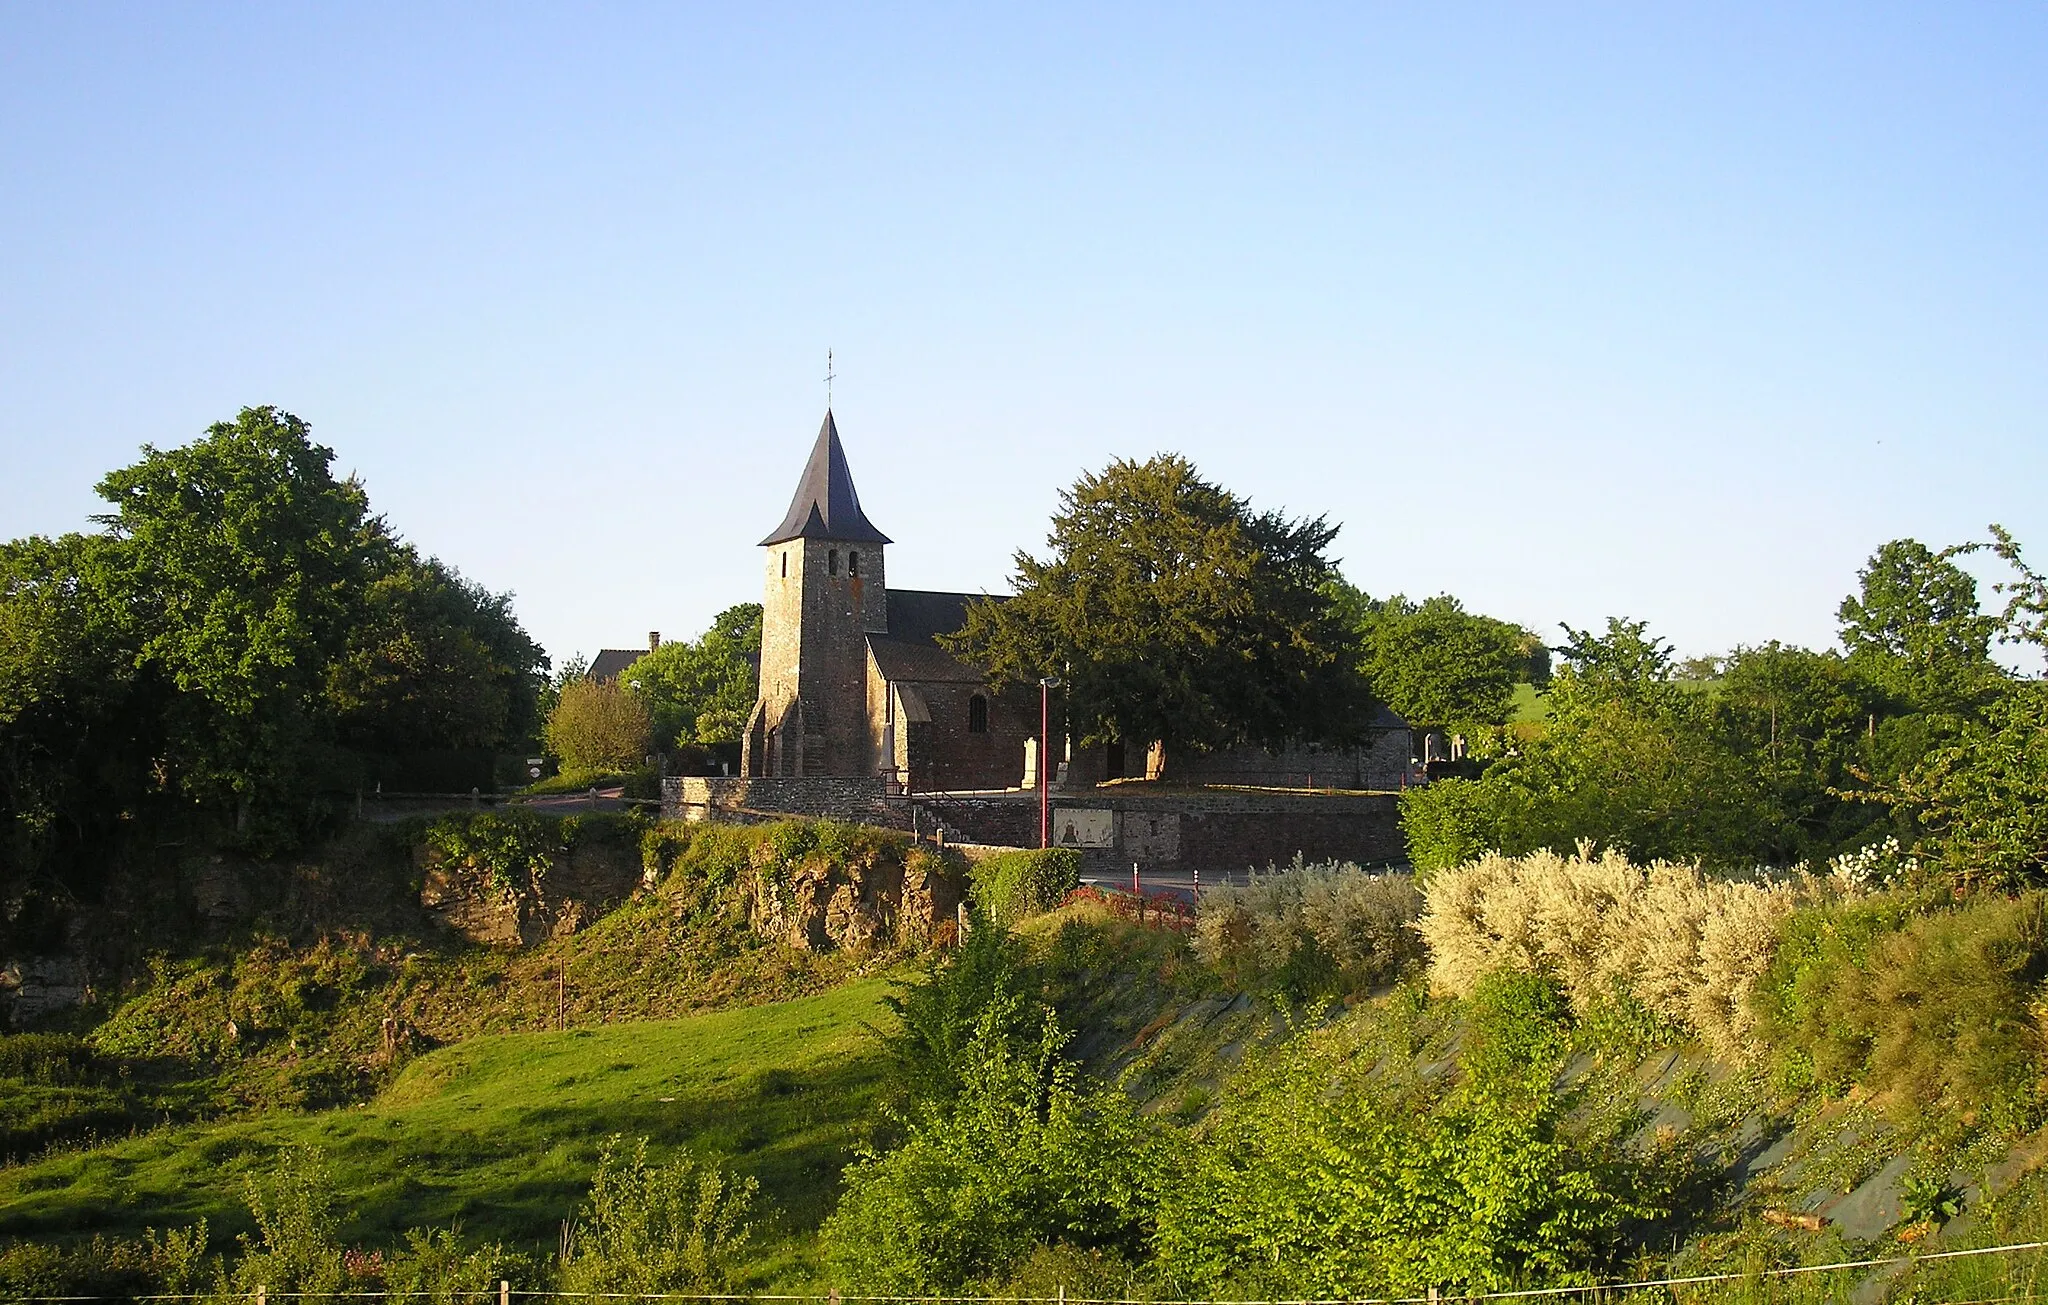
(741, 410, 1411, 793)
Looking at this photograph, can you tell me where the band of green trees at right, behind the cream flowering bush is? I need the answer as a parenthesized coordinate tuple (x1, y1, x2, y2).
(1403, 527, 2048, 883)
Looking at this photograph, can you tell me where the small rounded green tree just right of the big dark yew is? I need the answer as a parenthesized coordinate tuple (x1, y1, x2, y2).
(1360, 594, 1538, 727)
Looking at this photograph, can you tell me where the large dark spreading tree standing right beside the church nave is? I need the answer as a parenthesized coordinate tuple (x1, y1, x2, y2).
(948, 455, 1368, 770)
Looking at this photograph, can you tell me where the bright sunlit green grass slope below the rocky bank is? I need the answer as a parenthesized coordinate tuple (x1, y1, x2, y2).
(0, 979, 887, 1285)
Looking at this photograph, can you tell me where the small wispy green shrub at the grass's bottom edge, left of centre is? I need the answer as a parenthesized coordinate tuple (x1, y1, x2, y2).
(561, 1135, 760, 1293)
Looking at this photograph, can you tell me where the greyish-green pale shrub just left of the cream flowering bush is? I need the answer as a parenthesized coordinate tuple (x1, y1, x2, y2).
(1194, 856, 1421, 998)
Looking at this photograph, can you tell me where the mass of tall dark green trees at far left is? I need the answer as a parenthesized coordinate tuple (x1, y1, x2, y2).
(0, 408, 547, 881)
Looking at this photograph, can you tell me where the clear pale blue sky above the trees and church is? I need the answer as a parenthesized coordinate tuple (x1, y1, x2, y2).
(0, 4, 2048, 671)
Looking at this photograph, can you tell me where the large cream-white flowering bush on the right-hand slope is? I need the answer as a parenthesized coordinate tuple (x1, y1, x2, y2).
(1415, 844, 1825, 1057)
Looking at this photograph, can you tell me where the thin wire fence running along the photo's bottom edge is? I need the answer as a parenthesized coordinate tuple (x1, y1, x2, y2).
(8, 1241, 2048, 1305)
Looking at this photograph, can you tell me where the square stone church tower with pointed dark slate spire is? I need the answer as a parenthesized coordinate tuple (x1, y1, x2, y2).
(741, 410, 889, 774)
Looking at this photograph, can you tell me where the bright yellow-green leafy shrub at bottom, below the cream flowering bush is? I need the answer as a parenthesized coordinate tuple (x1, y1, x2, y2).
(1159, 973, 1677, 1299)
